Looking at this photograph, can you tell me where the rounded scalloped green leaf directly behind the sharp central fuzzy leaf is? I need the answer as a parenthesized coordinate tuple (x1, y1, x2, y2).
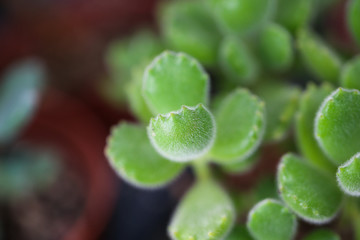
(143, 51, 209, 114)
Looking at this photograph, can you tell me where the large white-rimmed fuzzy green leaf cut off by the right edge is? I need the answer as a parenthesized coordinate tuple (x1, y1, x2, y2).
(315, 88, 360, 165)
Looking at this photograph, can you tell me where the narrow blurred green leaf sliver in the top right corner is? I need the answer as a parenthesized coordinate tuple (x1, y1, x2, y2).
(346, 0, 360, 46)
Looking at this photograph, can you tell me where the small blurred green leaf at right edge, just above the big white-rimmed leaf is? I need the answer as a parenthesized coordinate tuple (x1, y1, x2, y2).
(340, 56, 360, 90)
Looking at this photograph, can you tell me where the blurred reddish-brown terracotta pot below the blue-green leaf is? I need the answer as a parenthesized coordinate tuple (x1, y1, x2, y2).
(21, 90, 118, 240)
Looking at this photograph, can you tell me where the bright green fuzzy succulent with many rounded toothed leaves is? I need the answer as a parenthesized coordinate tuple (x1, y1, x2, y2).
(106, 0, 360, 240)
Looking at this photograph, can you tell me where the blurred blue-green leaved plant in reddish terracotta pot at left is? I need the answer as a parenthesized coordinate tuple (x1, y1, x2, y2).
(0, 58, 117, 240)
